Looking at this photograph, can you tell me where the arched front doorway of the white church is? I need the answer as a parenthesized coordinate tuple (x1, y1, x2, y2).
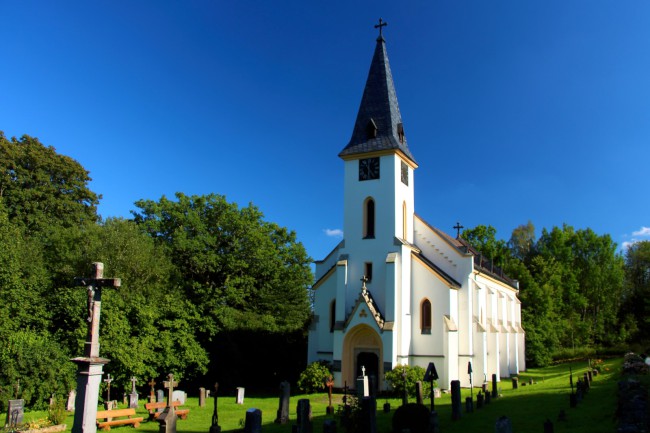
(341, 325, 384, 390)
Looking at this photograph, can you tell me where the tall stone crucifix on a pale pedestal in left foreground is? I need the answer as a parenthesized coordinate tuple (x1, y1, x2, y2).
(72, 262, 120, 433)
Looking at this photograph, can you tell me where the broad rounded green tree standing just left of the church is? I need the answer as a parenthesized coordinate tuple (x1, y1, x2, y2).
(134, 193, 313, 338)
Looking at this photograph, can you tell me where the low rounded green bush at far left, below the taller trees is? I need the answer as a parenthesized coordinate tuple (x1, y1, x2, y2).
(0, 330, 76, 410)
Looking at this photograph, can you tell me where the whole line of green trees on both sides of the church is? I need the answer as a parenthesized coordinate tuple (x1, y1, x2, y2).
(0, 132, 650, 408)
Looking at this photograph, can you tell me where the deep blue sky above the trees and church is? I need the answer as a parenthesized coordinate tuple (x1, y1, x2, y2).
(0, 0, 650, 259)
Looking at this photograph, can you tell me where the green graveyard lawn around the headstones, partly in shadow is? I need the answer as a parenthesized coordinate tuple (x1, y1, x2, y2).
(19, 359, 622, 433)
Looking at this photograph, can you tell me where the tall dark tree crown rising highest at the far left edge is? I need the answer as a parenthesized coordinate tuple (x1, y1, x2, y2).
(0, 131, 101, 233)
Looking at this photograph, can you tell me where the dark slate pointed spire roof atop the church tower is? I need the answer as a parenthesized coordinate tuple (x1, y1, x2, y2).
(339, 37, 415, 163)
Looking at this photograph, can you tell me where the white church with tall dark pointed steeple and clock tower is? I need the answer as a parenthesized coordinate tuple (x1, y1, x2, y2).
(308, 27, 526, 389)
